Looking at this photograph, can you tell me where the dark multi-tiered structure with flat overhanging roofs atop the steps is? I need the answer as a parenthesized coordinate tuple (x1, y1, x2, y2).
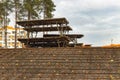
(16, 18, 83, 47)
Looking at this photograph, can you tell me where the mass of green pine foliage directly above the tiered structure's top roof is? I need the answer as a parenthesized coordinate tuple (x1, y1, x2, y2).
(18, 0, 55, 20)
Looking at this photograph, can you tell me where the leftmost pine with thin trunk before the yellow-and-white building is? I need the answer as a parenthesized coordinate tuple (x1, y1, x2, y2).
(0, 0, 12, 48)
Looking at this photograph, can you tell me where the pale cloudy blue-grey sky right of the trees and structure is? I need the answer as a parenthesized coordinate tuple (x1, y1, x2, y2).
(53, 0, 120, 46)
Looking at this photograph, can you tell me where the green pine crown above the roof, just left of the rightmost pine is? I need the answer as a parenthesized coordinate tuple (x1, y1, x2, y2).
(23, 0, 41, 20)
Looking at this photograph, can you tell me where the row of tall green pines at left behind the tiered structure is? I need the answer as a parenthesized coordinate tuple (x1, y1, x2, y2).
(0, 0, 56, 47)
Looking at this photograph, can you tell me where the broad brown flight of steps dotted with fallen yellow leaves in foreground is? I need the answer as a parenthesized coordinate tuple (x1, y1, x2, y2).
(0, 48, 120, 80)
